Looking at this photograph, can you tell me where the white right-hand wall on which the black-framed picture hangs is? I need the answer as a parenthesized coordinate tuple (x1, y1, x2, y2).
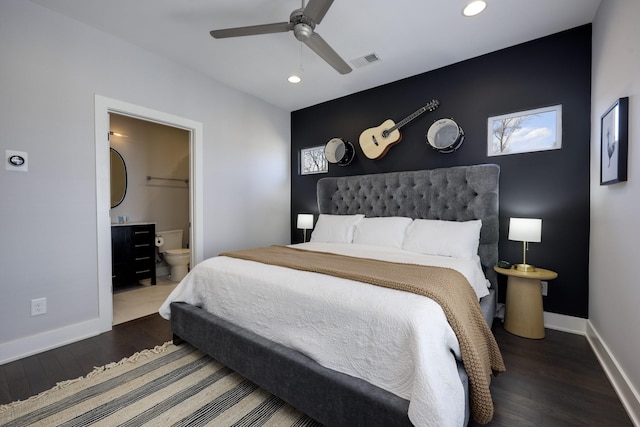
(589, 0, 640, 423)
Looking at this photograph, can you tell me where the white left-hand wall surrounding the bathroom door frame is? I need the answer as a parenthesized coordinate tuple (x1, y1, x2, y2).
(0, 0, 290, 363)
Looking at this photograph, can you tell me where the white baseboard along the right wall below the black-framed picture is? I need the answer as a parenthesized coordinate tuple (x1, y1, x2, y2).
(586, 321, 640, 426)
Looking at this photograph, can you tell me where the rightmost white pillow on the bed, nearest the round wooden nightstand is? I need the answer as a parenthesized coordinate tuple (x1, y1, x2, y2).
(402, 219, 482, 259)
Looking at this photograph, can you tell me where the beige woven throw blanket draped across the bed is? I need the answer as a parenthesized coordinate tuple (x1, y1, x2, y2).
(220, 246, 505, 424)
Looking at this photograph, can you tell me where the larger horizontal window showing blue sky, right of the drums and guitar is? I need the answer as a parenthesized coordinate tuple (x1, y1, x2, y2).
(487, 105, 562, 156)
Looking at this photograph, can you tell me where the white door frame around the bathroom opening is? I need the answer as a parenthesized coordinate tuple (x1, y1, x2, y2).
(95, 94, 204, 332)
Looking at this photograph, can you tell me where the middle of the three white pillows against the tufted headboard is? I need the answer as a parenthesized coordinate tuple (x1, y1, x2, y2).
(353, 216, 412, 248)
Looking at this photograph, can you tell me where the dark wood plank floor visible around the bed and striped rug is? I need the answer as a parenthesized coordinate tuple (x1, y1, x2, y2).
(0, 315, 633, 427)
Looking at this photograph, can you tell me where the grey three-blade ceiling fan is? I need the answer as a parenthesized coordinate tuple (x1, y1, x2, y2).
(209, 0, 351, 74)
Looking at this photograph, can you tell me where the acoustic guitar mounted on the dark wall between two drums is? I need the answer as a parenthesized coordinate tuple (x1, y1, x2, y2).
(360, 99, 440, 159)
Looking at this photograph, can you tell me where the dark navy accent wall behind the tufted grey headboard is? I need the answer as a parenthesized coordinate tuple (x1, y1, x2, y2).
(291, 25, 591, 318)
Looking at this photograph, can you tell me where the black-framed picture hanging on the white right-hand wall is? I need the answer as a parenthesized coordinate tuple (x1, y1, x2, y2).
(600, 98, 629, 185)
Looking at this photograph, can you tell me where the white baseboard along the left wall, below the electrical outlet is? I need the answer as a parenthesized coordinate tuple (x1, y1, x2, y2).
(0, 319, 111, 365)
